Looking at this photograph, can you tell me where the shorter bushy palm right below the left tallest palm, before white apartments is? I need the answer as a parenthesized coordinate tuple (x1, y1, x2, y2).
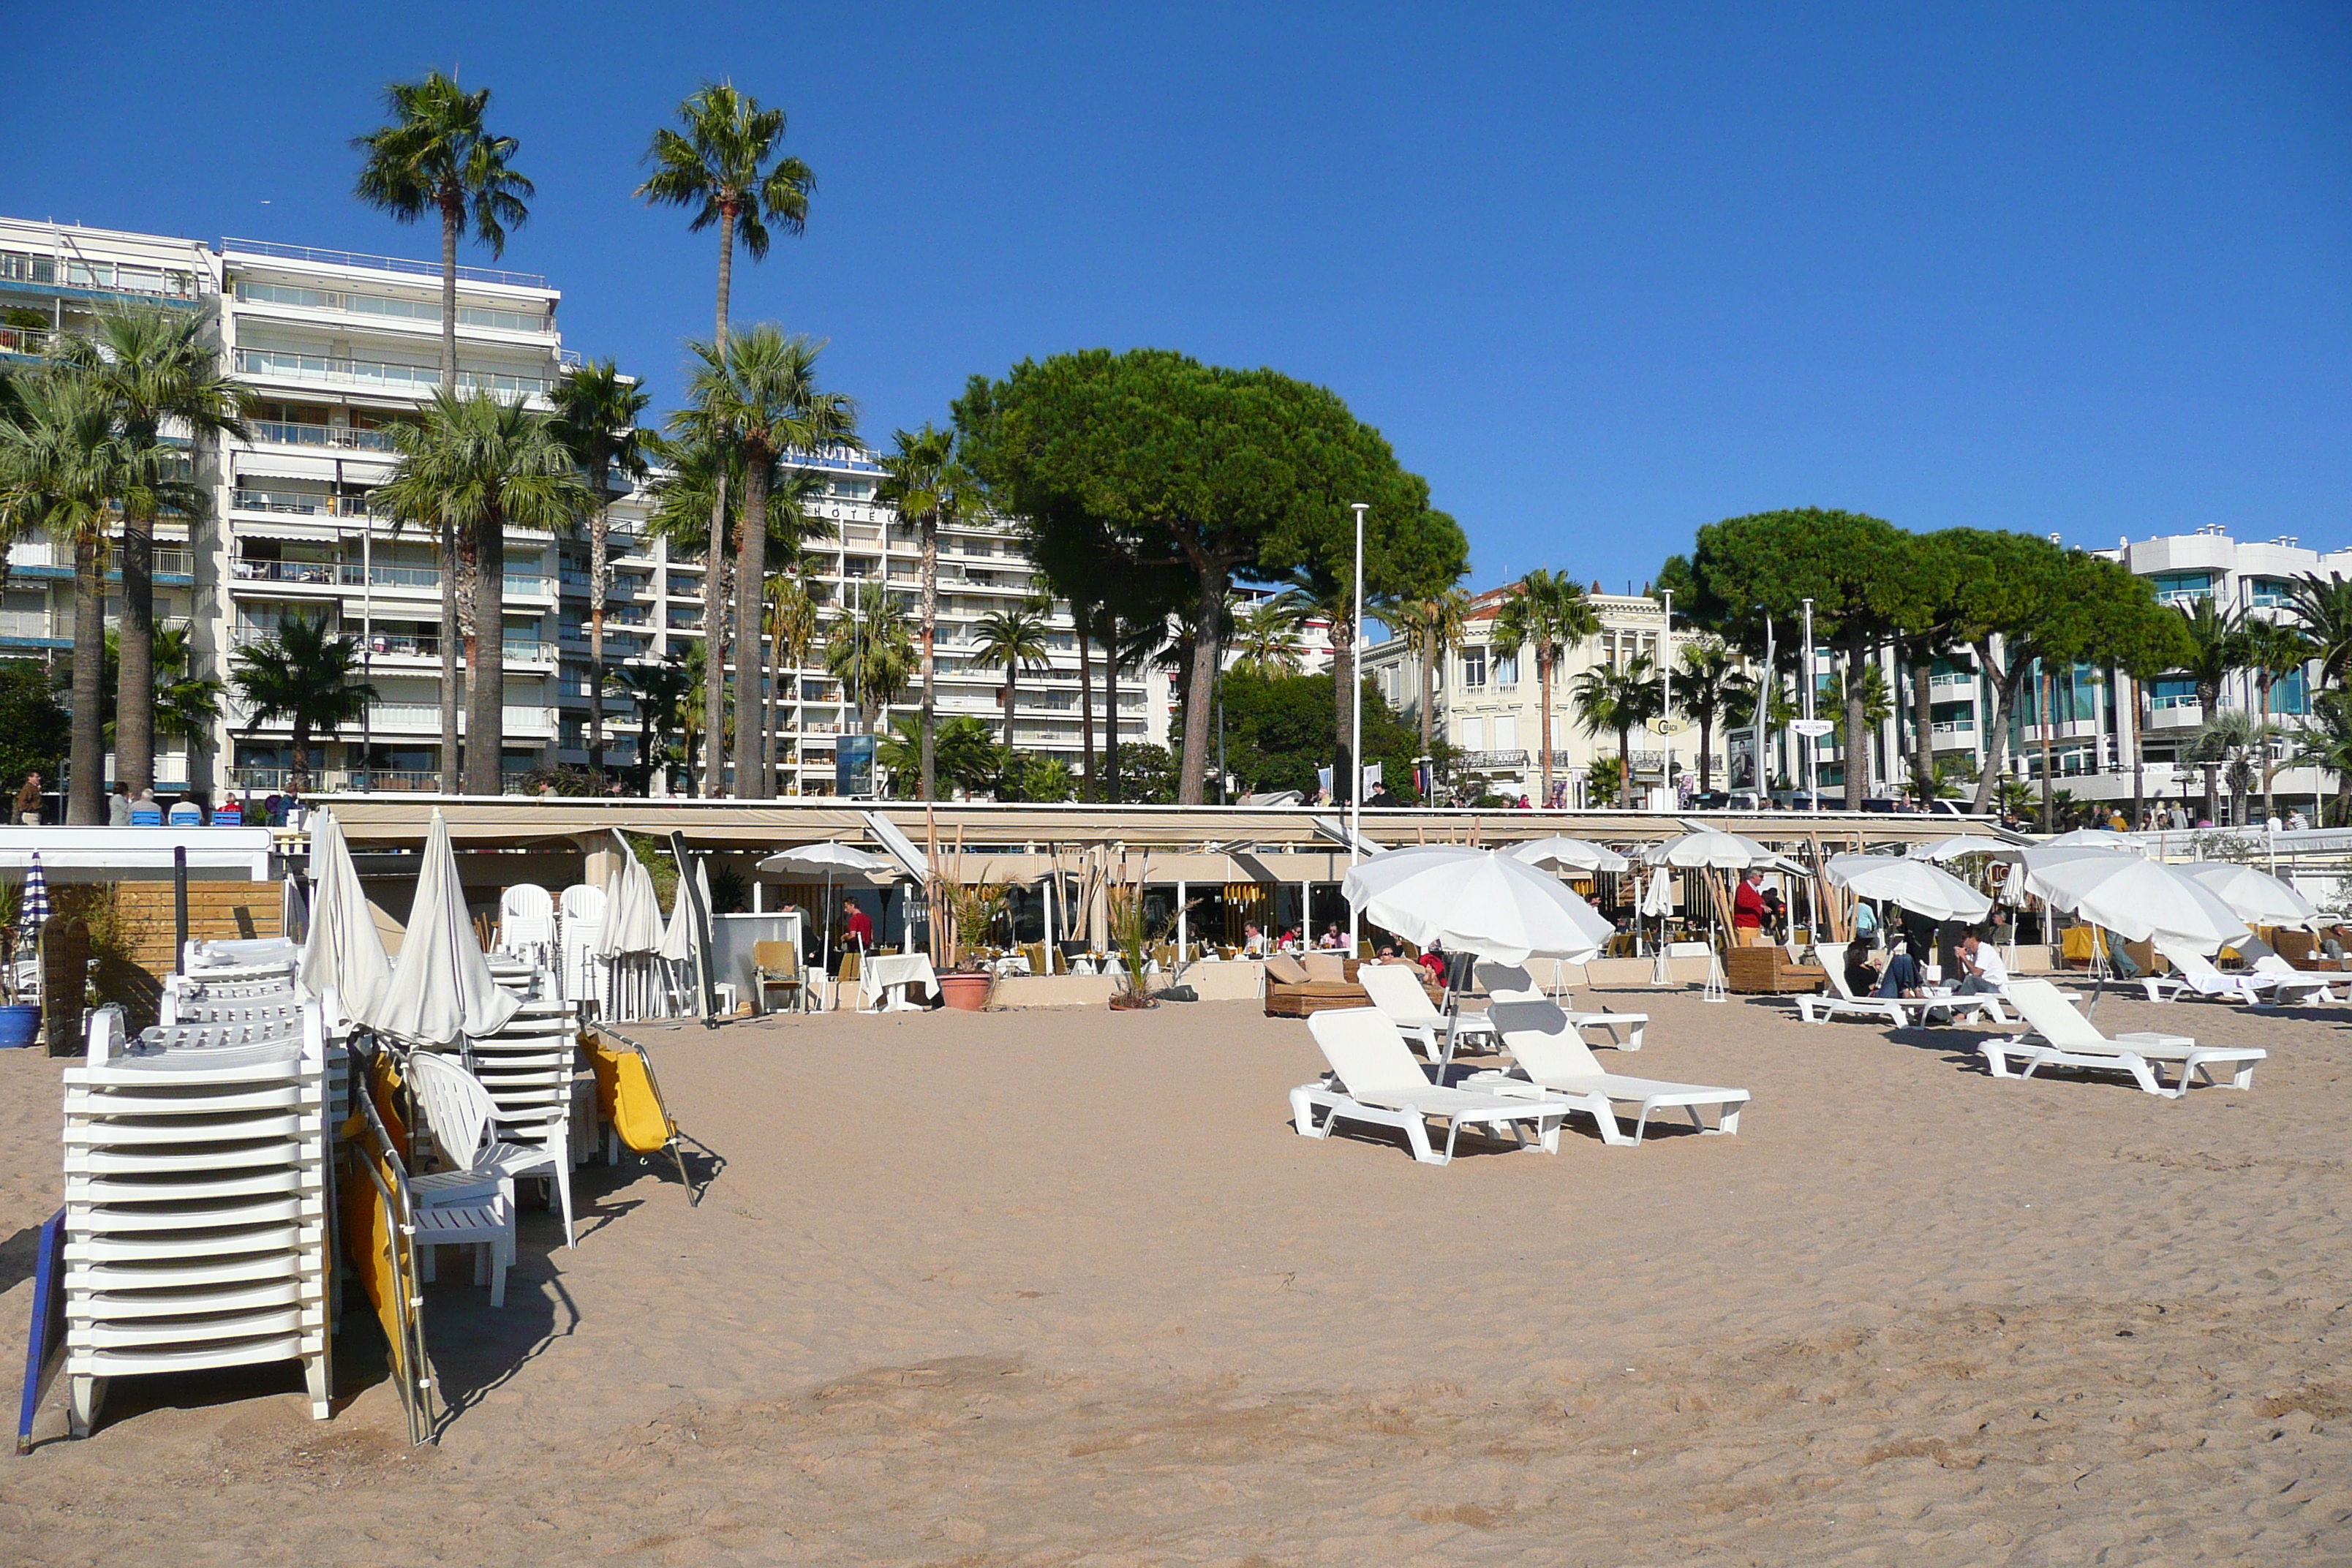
(374, 388, 595, 794)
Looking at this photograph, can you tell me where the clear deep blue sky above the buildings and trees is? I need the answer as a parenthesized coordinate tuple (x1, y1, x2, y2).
(0, 0, 2352, 588)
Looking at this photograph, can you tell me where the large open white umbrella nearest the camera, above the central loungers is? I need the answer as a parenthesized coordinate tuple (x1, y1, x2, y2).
(1341, 844, 1616, 964)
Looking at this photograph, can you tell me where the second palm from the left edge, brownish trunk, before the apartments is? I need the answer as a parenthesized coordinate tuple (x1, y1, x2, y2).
(59, 306, 247, 794)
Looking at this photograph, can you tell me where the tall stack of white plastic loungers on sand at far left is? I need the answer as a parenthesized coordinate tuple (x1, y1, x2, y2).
(66, 999, 331, 1436)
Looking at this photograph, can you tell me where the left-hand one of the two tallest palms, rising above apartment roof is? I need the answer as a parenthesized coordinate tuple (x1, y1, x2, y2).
(350, 70, 536, 794)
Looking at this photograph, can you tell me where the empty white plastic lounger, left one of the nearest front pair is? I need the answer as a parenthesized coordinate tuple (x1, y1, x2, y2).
(1292, 1006, 1569, 1166)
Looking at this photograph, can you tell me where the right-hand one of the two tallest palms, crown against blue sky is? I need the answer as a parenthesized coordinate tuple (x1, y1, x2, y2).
(638, 83, 816, 794)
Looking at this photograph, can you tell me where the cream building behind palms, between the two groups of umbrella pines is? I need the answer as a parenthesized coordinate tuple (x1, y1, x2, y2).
(1364, 585, 1727, 809)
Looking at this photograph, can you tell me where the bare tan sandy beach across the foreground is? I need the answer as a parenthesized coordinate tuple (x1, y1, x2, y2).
(0, 992, 2352, 1568)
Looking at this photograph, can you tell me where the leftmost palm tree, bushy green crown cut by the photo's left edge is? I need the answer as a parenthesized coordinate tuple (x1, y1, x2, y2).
(0, 369, 205, 827)
